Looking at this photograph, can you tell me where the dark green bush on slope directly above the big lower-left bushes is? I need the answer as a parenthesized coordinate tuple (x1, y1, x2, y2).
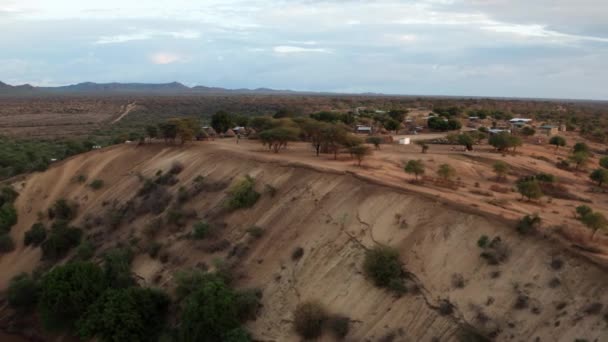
(41, 221, 82, 260)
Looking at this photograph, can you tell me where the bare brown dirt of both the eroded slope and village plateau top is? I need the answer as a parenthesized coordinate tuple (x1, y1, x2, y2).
(0, 138, 608, 341)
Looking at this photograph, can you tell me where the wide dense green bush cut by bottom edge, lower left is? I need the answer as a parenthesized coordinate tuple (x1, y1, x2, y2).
(77, 287, 170, 341)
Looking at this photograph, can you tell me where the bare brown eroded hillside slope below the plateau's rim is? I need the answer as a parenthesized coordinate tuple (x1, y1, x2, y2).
(0, 144, 608, 341)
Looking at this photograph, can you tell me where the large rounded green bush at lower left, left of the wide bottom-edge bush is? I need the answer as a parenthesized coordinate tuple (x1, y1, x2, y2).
(38, 262, 106, 331)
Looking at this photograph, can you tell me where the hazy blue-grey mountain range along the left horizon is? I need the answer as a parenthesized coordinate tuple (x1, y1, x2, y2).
(0, 82, 319, 95)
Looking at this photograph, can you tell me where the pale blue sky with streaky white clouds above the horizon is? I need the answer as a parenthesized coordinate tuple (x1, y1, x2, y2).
(0, 0, 608, 100)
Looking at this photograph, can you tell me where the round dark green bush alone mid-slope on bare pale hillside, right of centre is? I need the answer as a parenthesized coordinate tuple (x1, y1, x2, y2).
(363, 246, 403, 287)
